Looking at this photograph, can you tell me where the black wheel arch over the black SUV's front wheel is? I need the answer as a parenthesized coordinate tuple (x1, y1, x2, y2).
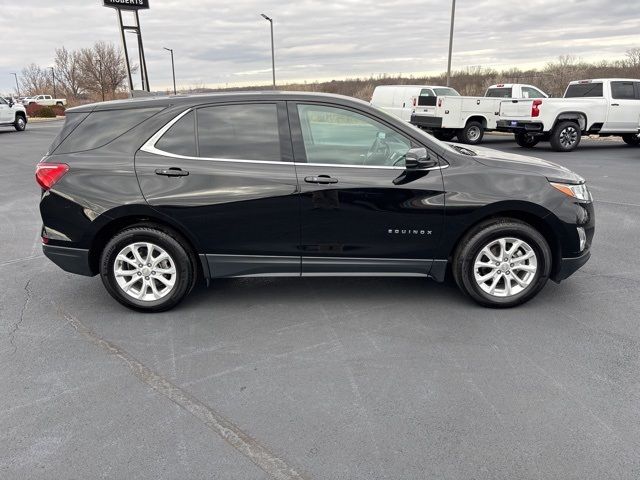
(447, 202, 562, 278)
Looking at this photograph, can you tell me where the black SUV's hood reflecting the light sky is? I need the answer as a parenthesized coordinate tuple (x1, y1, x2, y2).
(450, 144, 584, 184)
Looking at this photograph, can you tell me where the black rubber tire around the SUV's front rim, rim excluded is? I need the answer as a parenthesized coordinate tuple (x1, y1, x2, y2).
(452, 218, 552, 308)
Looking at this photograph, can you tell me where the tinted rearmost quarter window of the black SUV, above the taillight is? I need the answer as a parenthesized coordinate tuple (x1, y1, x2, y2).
(56, 107, 162, 153)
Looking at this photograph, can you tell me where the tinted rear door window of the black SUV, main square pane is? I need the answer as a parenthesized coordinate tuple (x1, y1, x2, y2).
(198, 103, 282, 161)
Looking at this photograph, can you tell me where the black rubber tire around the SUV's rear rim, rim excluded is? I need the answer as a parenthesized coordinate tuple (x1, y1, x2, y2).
(100, 226, 197, 312)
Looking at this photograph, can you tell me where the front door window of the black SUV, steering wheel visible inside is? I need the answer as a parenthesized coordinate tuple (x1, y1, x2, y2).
(298, 105, 411, 166)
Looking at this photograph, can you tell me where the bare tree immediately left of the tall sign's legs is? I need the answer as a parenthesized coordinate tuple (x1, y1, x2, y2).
(77, 41, 127, 100)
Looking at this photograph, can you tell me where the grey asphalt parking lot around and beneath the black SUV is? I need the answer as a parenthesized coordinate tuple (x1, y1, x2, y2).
(0, 122, 640, 480)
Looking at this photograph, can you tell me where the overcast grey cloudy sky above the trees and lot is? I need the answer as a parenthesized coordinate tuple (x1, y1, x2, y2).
(0, 0, 640, 92)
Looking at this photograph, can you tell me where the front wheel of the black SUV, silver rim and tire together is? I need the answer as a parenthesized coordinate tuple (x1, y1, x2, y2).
(452, 218, 552, 308)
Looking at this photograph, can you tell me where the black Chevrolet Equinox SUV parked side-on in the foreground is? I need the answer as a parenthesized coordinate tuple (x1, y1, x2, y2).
(36, 92, 594, 311)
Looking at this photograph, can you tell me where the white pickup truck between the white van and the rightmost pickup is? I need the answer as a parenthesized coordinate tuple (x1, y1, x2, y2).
(411, 83, 547, 145)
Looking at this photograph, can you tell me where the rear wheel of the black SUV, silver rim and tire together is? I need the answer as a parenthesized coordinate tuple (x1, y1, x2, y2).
(100, 227, 196, 312)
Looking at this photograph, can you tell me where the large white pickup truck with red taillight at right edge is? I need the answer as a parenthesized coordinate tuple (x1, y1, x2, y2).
(498, 78, 640, 152)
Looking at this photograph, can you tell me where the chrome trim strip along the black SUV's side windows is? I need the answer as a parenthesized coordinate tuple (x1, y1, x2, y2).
(140, 108, 449, 172)
